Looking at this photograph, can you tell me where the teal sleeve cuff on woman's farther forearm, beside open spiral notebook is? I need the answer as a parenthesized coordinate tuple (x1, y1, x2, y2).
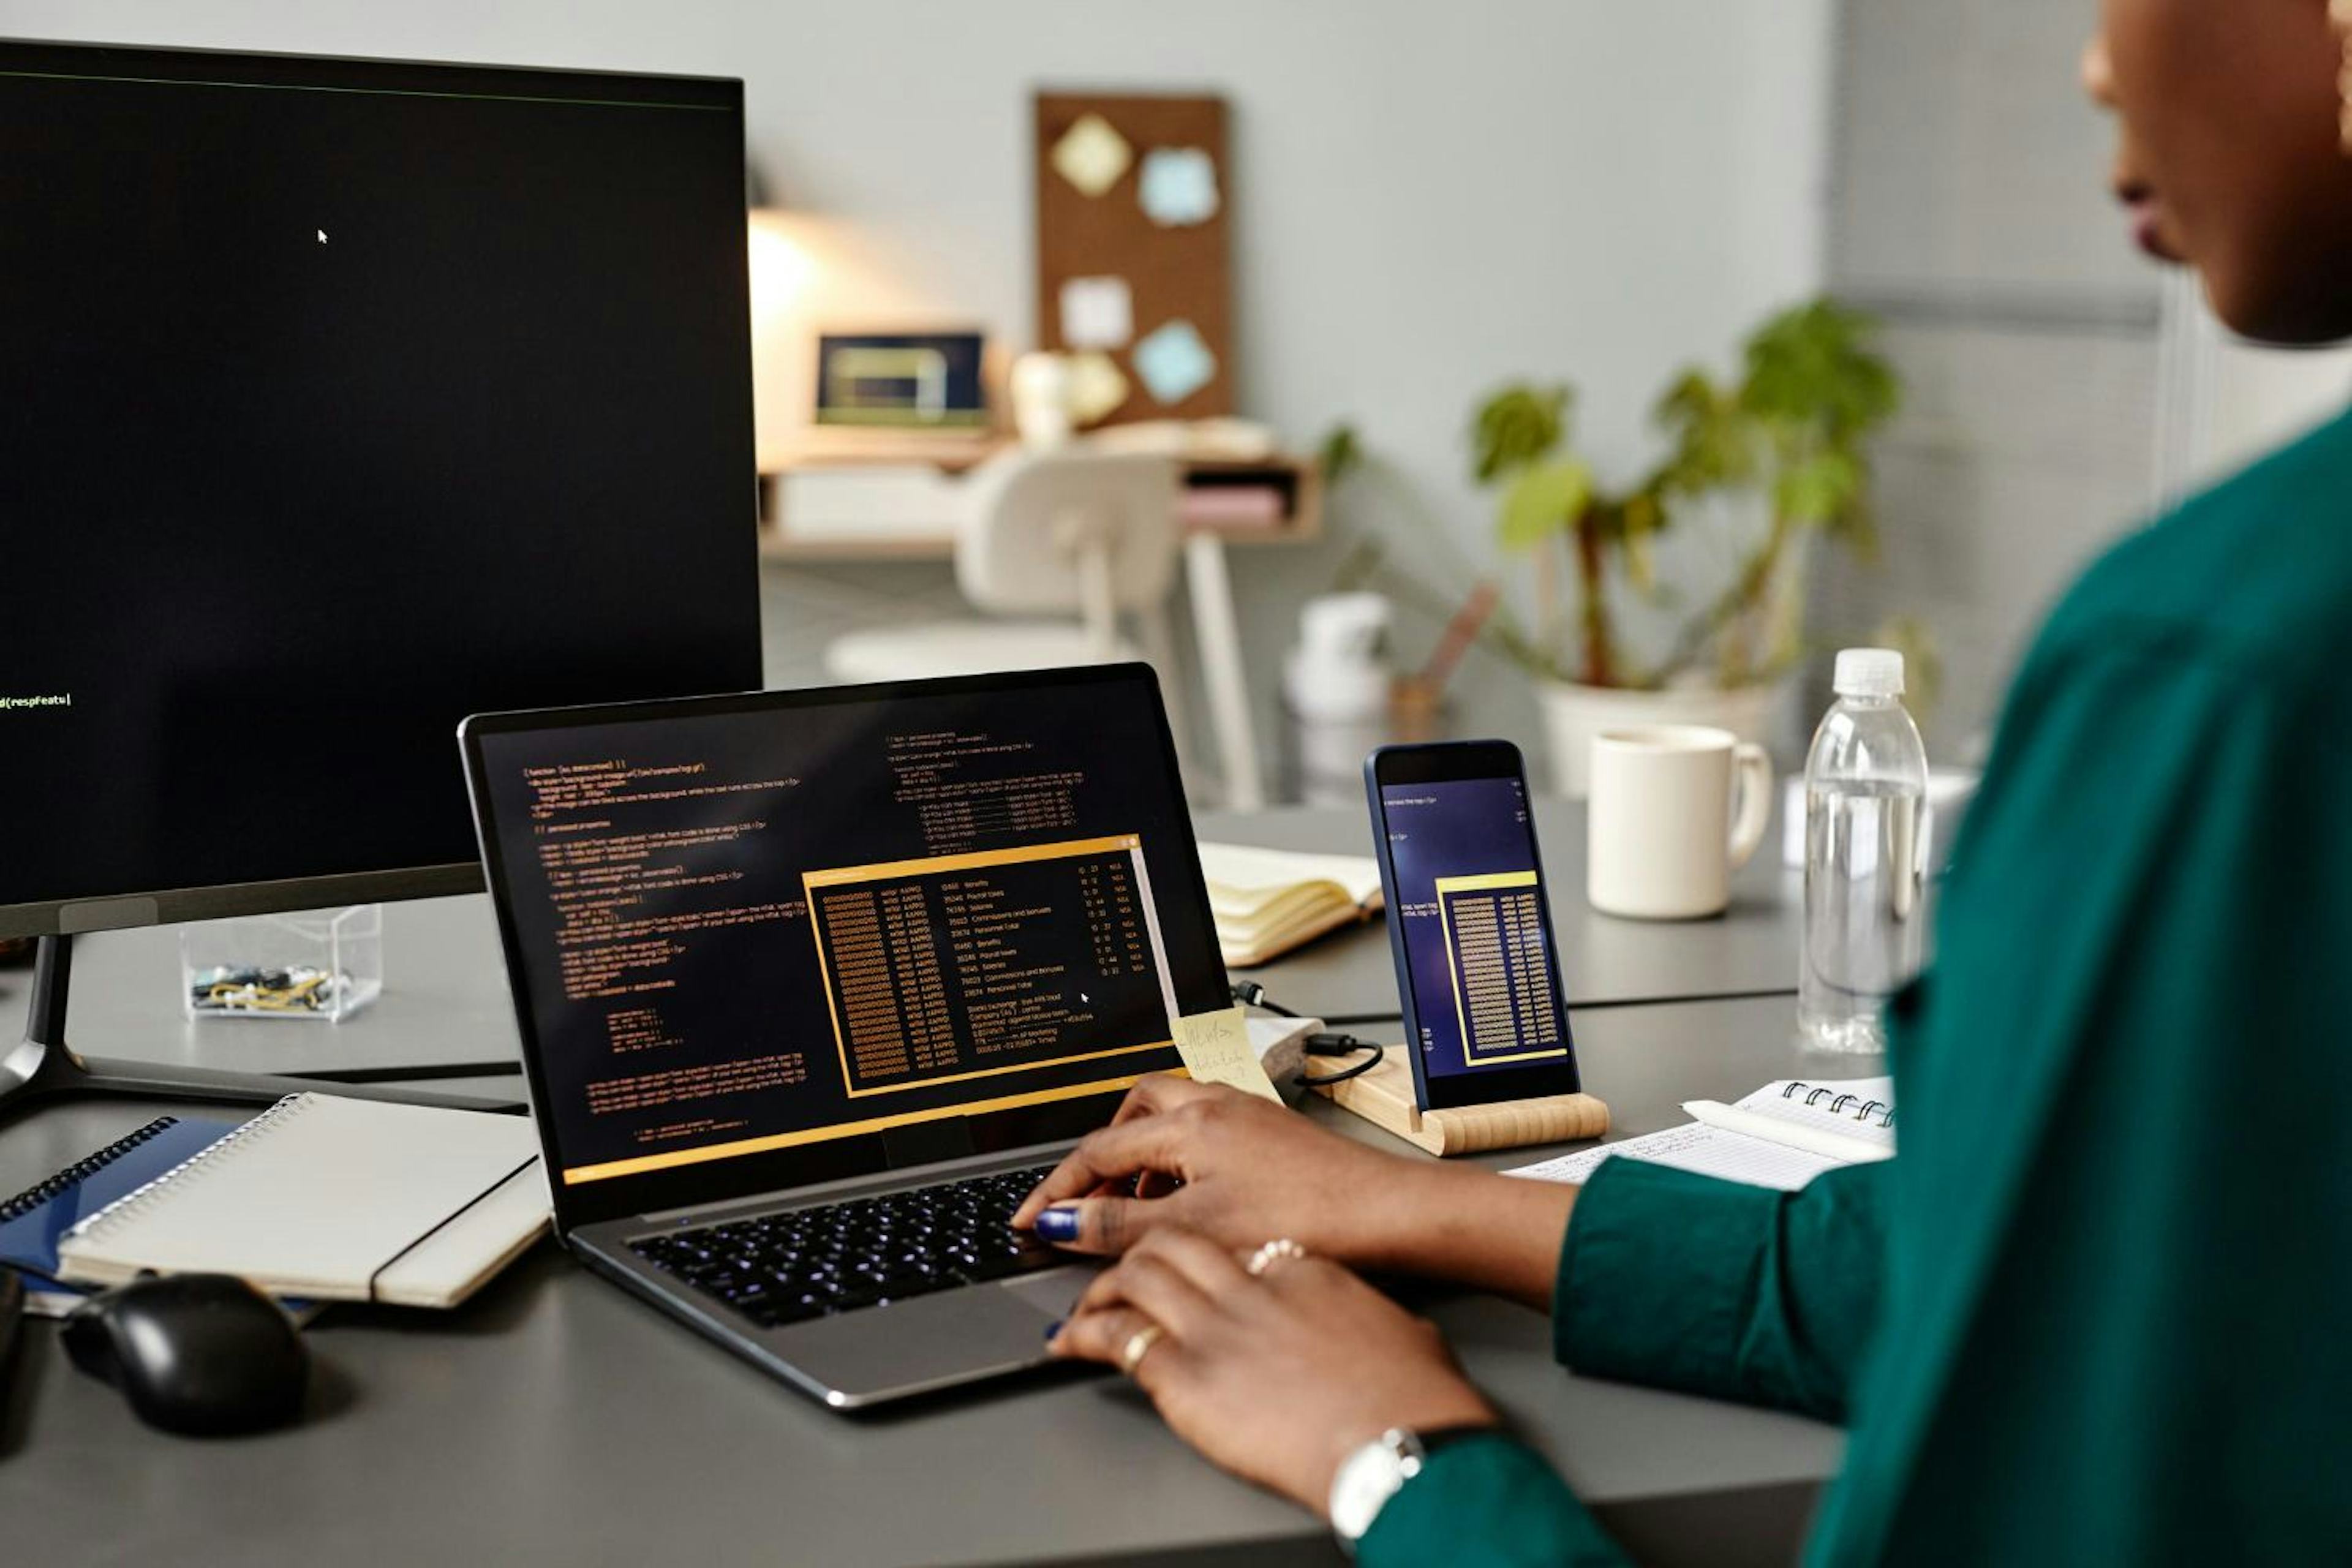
(1552, 1159, 1893, 1420)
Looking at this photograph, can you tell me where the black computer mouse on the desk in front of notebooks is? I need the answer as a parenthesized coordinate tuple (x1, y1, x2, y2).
(61, 1274, 311, 1436)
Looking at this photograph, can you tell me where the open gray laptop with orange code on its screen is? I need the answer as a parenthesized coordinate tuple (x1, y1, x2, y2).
(459, 665, 1230, 1408)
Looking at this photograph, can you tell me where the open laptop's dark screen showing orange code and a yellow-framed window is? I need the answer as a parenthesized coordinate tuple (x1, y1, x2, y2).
(466, 665, 1226, 1222)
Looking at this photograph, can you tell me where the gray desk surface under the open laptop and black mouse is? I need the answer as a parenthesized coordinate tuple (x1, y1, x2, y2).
(0, 995, 1868, 1568)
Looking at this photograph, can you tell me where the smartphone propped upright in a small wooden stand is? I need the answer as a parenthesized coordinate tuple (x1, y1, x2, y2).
(1364, 741, 1580, 1110)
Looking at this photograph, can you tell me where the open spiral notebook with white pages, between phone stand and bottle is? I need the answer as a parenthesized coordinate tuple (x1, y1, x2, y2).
(1506, 1079, 1896, 1192)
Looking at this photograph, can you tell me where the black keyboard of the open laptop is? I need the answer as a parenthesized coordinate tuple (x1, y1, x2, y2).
(628, 1166, 1070, 1329)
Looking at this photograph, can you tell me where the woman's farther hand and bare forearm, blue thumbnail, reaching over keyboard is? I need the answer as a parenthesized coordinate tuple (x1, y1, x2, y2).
(1014, 1074, 1576, 1310)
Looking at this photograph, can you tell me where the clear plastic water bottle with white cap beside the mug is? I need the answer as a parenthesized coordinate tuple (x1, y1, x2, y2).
(1797, 649, 1926, 1051)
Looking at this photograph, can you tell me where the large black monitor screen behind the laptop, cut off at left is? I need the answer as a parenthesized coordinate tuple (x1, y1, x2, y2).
(0, 45, 760, 933)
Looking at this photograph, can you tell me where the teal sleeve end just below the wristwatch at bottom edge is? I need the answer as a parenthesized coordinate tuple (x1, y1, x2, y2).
(1355, 1431, 1627, 1568)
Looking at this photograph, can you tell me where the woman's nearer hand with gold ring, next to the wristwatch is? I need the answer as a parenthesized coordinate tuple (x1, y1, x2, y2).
(1051, 1229, 1496, 1514)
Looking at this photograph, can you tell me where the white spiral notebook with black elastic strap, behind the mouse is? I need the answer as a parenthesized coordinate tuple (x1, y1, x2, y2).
(56, 1093, 548, 1307)
